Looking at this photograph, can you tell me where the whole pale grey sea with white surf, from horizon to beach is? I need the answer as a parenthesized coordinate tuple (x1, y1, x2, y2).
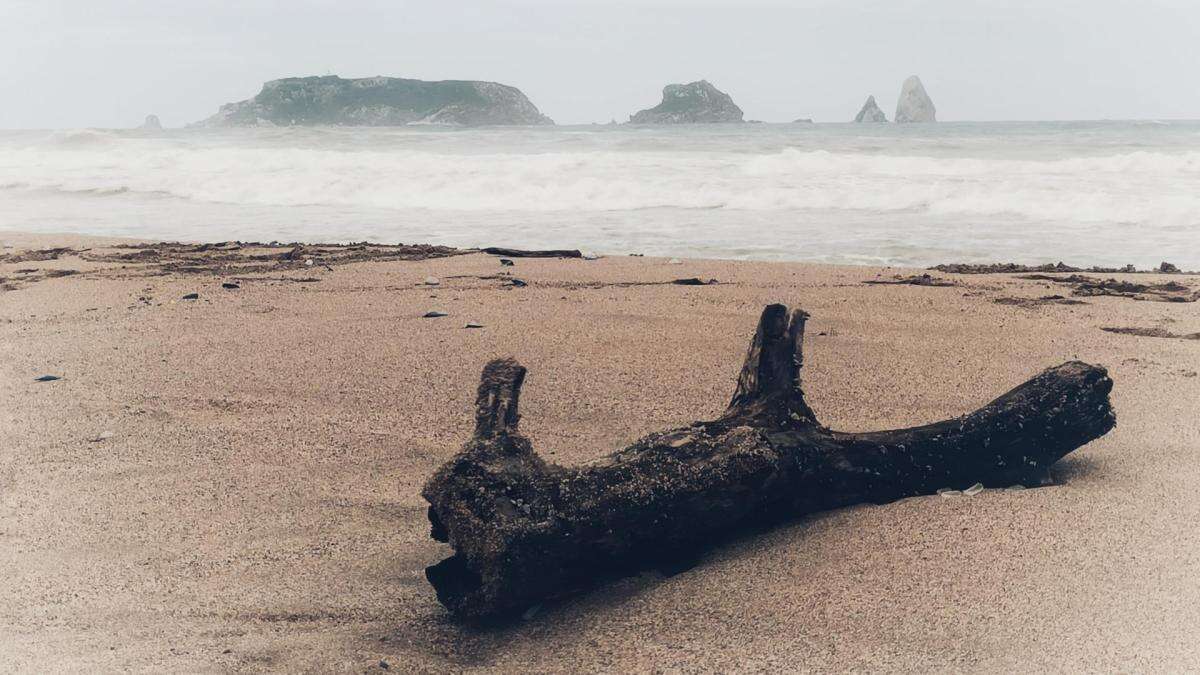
(0, 121, 1200, 269)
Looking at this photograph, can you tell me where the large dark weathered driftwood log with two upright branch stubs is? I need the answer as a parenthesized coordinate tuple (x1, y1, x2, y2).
(424, 305, 1116, 619)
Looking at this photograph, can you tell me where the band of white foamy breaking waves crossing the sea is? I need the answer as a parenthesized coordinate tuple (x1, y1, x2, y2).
(0, 139, 1200, 225)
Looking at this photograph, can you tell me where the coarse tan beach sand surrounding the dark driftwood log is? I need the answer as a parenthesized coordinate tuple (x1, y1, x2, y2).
(0, 234, 1200, 671)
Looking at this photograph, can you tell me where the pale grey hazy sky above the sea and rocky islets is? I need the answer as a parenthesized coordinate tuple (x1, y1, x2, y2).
(0, 0, 1200, 129)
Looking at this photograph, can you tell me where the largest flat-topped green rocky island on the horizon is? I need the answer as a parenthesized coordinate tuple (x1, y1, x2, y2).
(199, 76, 554, 126)
